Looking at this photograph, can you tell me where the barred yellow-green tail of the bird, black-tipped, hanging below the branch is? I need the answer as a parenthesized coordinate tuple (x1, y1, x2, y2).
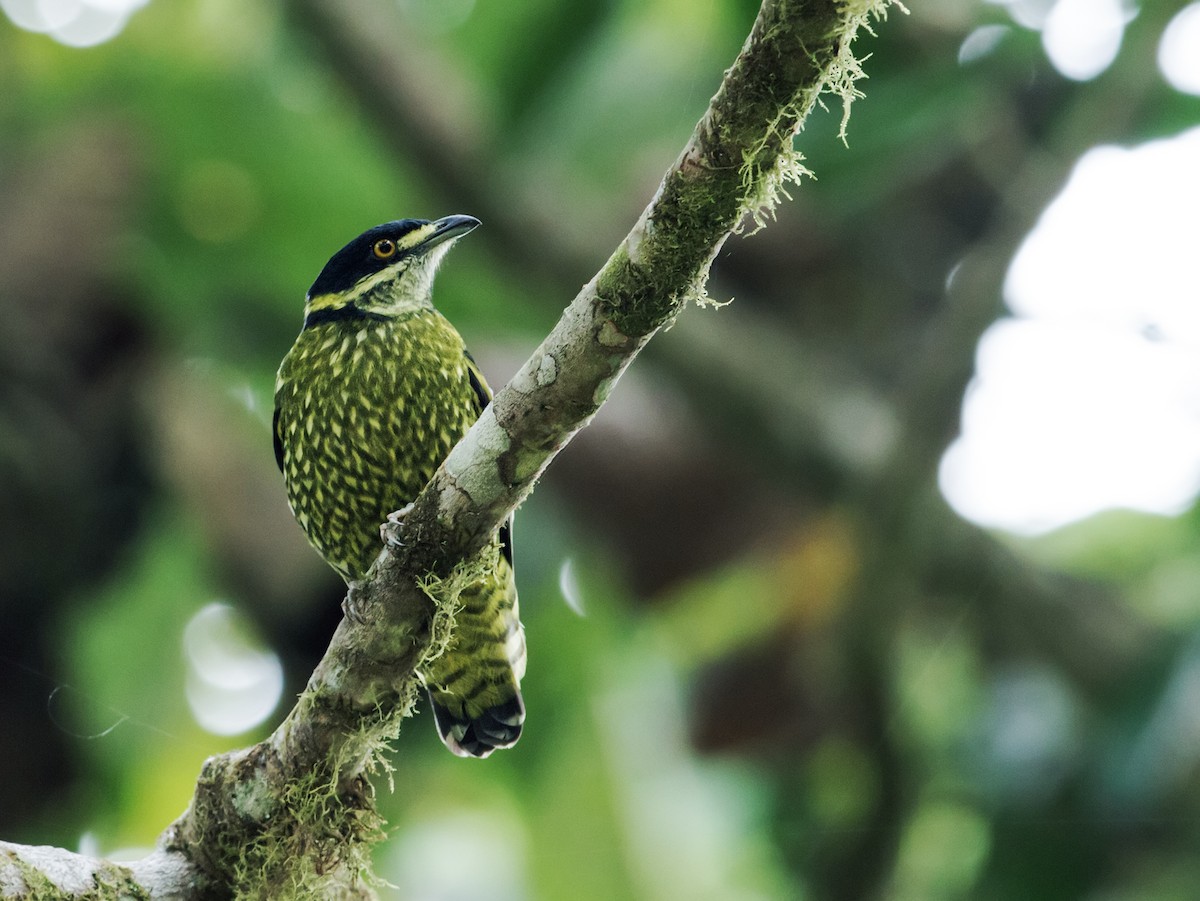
(425, 561, 526, 757)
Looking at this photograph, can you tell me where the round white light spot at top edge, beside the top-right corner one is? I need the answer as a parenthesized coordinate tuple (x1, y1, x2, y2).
(1042, 0, 1128, 82)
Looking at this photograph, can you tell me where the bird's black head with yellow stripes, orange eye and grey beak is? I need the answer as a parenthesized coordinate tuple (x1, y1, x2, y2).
(305, 216, 479, 320)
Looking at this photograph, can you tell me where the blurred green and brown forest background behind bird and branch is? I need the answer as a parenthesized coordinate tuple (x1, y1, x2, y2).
(0, 0, 1200, 901)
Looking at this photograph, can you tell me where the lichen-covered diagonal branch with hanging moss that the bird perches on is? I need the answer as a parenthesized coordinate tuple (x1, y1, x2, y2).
(0, 0, 892, 897)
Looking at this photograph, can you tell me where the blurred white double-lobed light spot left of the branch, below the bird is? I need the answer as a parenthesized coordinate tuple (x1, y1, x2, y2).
(184, 602, 283, 735)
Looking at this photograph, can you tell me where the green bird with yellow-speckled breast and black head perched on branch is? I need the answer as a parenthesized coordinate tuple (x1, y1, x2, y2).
(274, 216, 526, 757)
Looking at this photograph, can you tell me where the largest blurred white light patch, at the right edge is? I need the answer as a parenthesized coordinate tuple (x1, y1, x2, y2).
(941, 128, 1200, 533)
